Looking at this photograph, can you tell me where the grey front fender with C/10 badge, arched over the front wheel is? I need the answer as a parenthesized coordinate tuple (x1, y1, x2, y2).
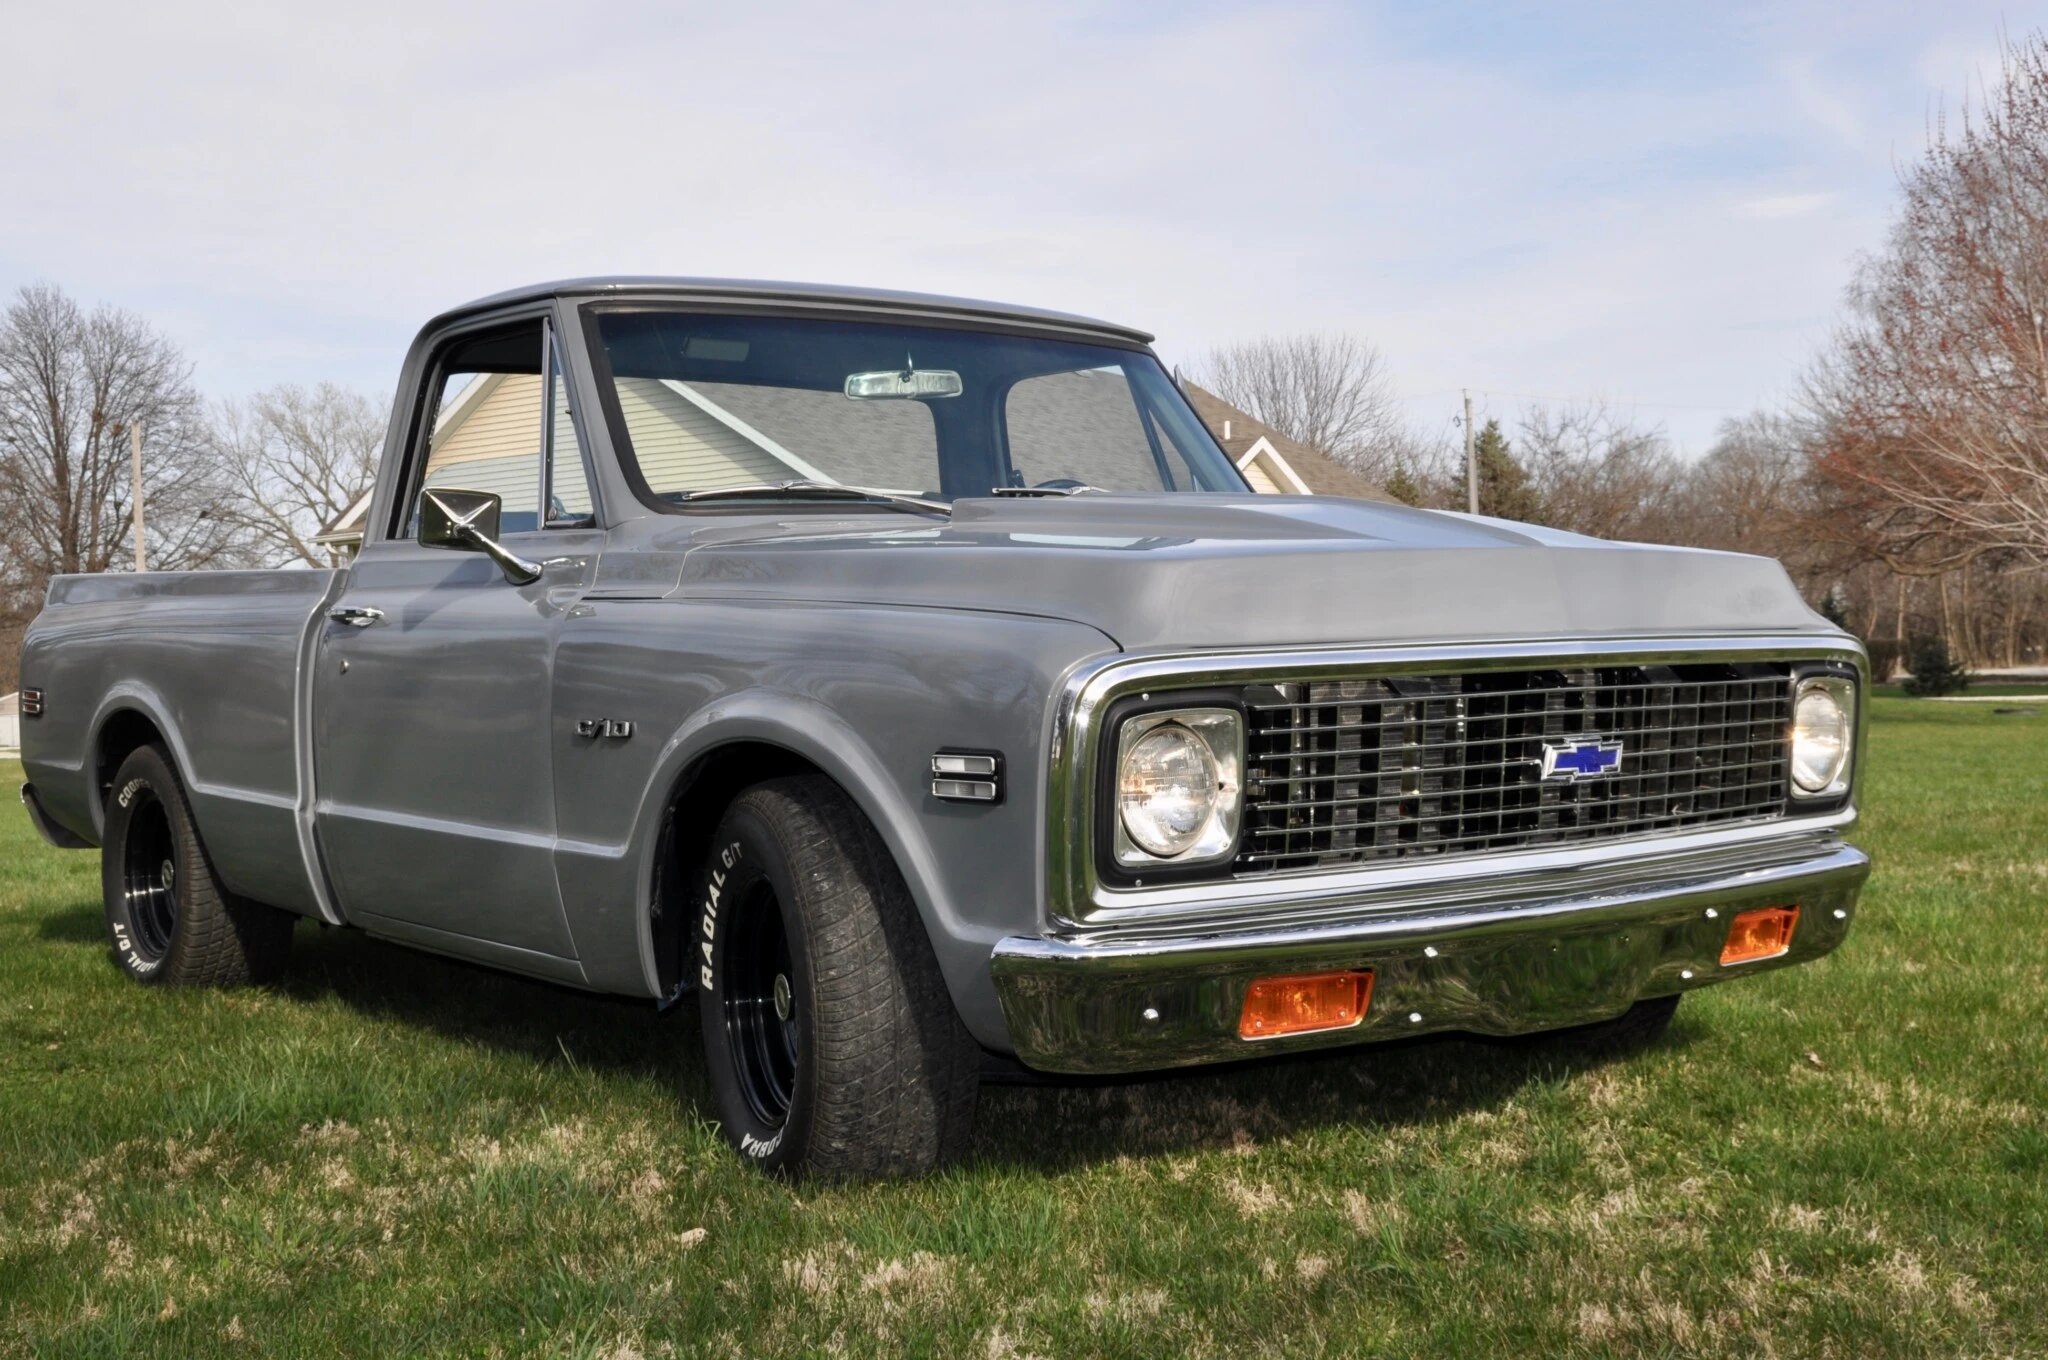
(555, 600, 1108, 1049)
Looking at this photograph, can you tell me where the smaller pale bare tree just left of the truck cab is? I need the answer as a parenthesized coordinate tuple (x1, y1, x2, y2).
(213, 383, 385, 567)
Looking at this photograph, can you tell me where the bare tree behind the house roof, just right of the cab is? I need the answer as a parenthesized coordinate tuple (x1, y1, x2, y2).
(1196, 334, 1401, 481)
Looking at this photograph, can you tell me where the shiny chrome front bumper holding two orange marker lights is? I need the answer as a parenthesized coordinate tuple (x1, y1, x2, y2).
(991, 842, 1870, 1073)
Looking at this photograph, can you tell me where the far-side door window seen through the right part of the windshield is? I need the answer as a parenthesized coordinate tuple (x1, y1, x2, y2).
(1004, 367, 1186, 492)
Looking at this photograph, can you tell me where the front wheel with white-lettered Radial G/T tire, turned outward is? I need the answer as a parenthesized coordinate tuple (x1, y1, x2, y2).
(690, 776, 981, 1178)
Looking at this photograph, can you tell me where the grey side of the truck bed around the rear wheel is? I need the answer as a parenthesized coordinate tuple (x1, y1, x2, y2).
(20, 569, 340, 916)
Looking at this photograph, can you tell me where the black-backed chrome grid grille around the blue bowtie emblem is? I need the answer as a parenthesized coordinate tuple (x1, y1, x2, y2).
(1235, 662, 1792, 873)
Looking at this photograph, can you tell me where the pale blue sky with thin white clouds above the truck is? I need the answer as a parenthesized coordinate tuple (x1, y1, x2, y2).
(0, 0, 2048, 453)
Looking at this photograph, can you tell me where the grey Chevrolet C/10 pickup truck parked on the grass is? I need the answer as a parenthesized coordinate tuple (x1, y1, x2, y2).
(23, 279, 1868, 1176)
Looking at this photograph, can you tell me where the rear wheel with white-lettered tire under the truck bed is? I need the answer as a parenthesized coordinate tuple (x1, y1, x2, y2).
(100, 746, 295, 987)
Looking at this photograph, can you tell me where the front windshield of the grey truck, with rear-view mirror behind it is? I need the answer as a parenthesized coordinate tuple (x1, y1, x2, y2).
(596, 311, 1245, 504)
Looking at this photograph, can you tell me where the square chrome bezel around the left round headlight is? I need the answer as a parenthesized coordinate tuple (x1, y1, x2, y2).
(1096, 690, 1247, 887)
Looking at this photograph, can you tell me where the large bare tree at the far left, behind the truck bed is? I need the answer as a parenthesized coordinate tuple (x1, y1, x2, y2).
(0, 285, 238, 596)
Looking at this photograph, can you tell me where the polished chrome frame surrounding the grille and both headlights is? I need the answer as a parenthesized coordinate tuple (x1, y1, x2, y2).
(1044, 633, 1870, 930)
